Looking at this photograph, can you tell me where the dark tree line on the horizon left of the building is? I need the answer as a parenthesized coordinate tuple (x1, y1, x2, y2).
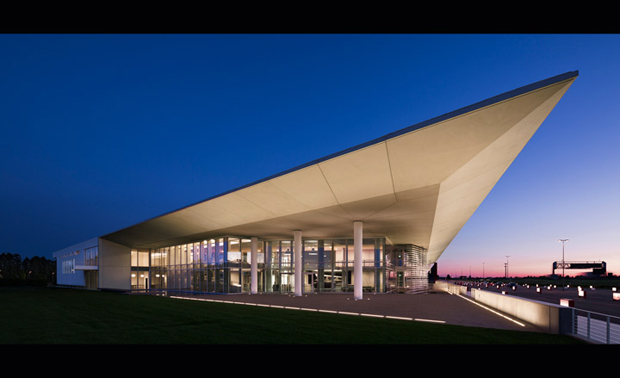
(0, 253, 56, 285)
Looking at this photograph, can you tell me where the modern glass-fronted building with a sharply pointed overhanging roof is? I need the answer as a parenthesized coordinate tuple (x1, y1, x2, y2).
(54, 72, 578, 299)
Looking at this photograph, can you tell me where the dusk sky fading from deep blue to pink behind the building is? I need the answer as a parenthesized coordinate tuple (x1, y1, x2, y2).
(0, 34, 620, 276)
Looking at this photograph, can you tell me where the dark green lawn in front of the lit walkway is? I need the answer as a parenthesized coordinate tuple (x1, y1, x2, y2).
(0, 288, 581, 345)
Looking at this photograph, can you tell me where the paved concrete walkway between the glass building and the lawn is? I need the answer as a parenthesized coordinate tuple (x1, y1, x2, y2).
(170, 293, 542, 332)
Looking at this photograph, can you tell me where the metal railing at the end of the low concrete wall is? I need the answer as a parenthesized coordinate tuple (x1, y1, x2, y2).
(572, 309, 620, 344)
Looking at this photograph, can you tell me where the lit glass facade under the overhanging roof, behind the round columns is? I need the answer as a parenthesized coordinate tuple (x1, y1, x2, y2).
(143, 236, 423, 293)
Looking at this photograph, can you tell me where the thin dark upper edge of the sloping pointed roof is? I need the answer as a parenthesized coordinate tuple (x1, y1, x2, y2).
(102, 71, 579, 237)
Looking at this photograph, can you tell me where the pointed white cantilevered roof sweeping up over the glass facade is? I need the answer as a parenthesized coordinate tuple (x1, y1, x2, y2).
(102, 72, 578, 263)
